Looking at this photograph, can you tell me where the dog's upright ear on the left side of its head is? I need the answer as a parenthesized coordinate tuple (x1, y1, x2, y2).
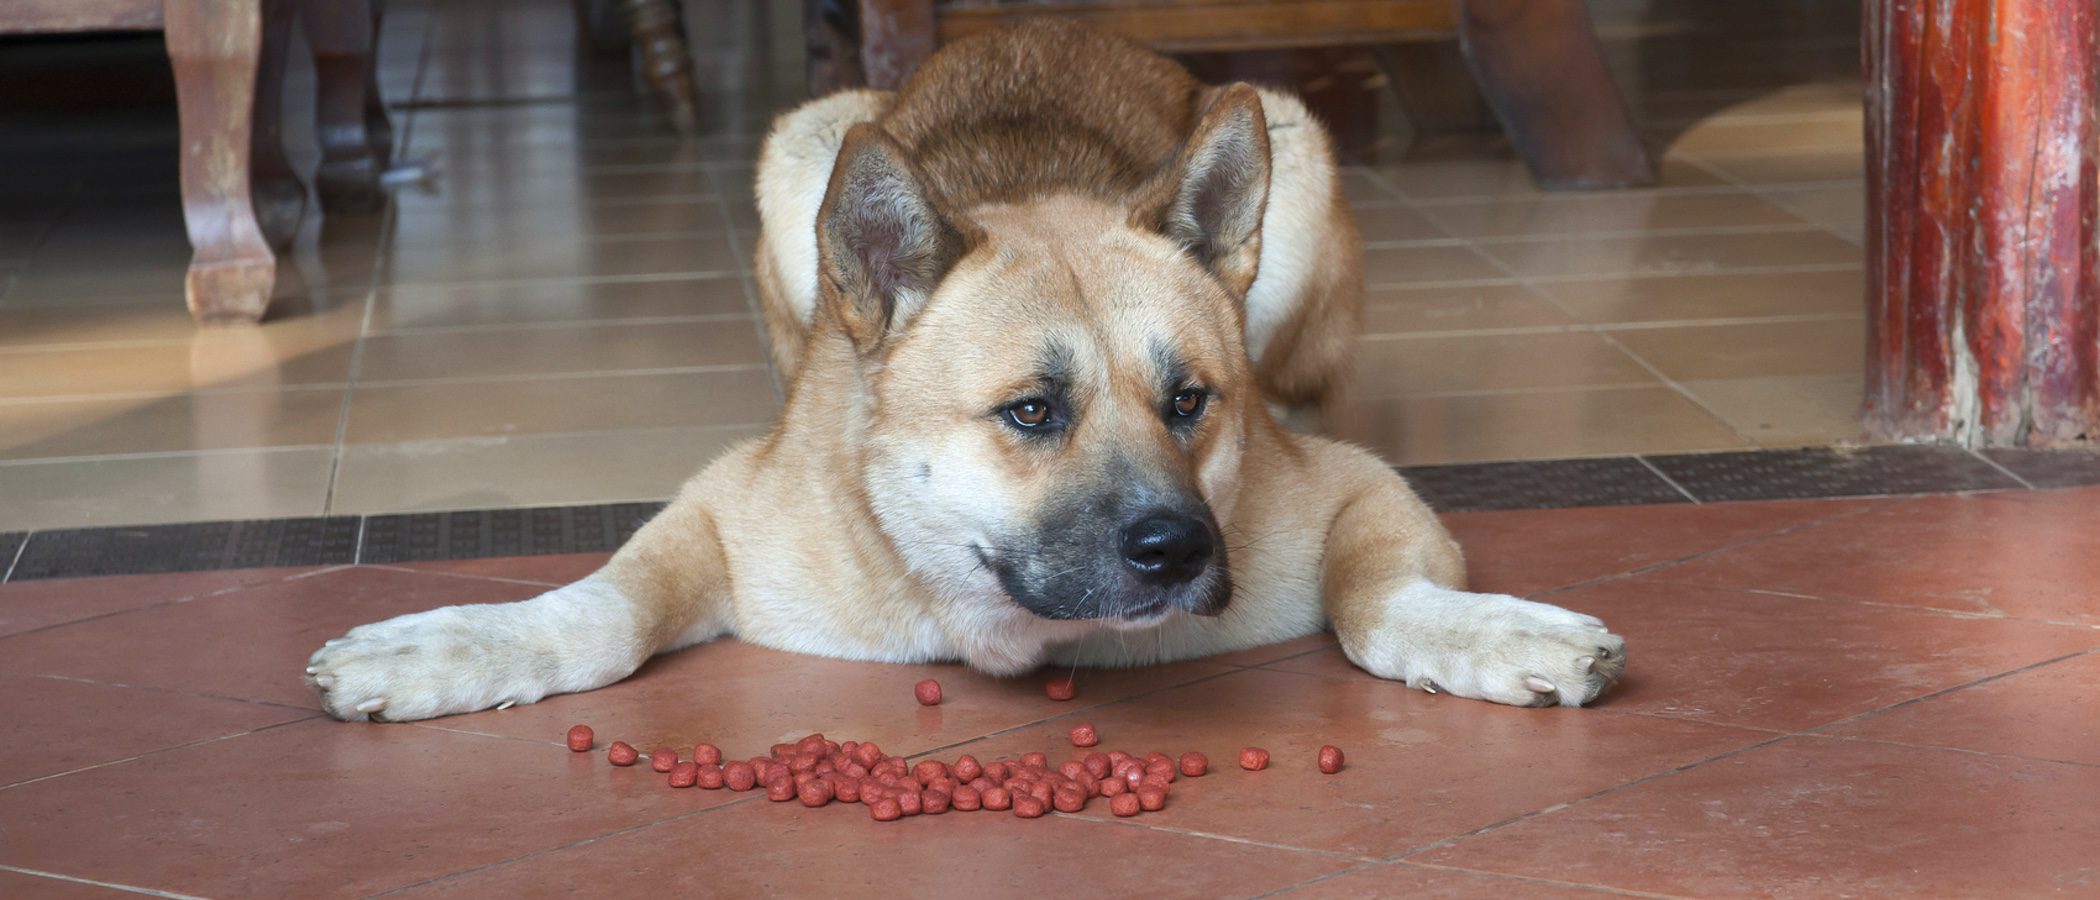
(817, 122, 964, 352)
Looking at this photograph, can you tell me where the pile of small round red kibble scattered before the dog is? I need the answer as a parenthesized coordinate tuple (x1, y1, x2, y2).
(569, 680, 1342, 822)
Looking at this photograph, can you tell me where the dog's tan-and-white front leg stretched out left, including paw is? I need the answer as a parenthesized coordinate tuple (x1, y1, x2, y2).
(307, 491, 729, 722)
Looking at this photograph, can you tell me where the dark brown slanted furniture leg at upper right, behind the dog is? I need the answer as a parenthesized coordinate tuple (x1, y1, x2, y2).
(1453, 0, 1655, 191)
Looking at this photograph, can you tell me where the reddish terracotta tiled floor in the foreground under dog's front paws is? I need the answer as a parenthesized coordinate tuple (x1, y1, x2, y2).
(0, 489, 2100, 898)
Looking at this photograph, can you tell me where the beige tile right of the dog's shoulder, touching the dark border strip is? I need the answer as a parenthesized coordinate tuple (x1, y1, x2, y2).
(1331, 381, 1749, 466)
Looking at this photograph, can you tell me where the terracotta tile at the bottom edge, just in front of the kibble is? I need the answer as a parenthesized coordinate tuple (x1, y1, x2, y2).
(386, 780, 1352, 898)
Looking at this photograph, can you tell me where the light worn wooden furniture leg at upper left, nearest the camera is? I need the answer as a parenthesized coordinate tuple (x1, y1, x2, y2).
(166, 0, 284, 323)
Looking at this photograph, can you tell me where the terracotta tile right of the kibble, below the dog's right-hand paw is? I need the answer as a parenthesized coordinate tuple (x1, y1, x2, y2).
(941, 663, 1762, 858)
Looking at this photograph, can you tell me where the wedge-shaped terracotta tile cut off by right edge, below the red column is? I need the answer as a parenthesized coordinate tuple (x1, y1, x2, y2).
(1829, 652, 2100, 766)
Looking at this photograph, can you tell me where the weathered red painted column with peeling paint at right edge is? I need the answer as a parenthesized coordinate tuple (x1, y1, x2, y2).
(1861, 0, 2100, 447)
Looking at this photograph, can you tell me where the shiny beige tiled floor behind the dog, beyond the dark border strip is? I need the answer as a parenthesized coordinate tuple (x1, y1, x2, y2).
(0, 0, 1863, 531)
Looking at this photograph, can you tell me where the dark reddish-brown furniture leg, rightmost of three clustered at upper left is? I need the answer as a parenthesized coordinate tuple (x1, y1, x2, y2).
(300, 0, 386, 214)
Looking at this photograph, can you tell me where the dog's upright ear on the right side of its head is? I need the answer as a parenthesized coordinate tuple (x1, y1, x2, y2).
(1130, 84, 1268, 298)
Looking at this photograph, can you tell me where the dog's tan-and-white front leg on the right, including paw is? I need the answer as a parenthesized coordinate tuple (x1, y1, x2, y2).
(1321, 447, 1625, 707)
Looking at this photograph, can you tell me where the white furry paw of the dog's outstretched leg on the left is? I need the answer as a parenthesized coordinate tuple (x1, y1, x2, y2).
(307, 606, 542, 722)
